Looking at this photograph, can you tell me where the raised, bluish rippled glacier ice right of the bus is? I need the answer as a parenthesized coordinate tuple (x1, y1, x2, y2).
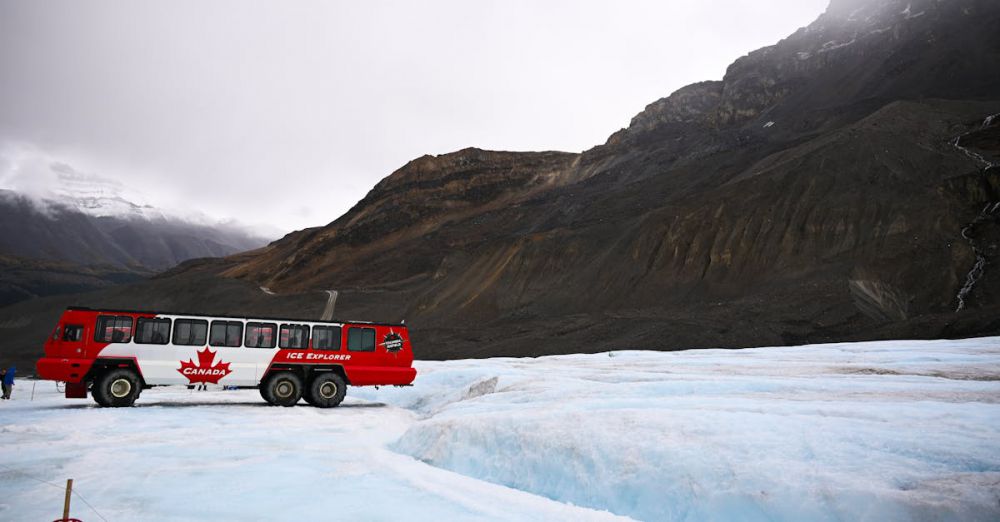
(360, 338, 1000, 520)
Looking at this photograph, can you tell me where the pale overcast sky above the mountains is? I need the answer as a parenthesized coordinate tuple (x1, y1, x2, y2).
(0, 0, 828, 236)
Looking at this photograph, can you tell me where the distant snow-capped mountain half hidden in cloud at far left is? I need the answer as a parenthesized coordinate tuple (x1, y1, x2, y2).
(0, 154, 273, 306)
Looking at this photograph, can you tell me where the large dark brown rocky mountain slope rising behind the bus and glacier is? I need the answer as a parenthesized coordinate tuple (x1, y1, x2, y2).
(1, 0, 1000, 370)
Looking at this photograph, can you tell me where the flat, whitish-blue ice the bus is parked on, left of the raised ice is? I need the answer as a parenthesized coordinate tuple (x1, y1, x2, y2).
(0, 381, 615, 522)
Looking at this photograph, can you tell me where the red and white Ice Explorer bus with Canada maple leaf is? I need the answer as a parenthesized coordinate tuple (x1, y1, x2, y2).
(37, 307, 417, 408)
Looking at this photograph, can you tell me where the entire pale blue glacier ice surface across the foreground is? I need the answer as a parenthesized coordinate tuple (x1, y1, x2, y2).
(0, 338, 1000, 521)
